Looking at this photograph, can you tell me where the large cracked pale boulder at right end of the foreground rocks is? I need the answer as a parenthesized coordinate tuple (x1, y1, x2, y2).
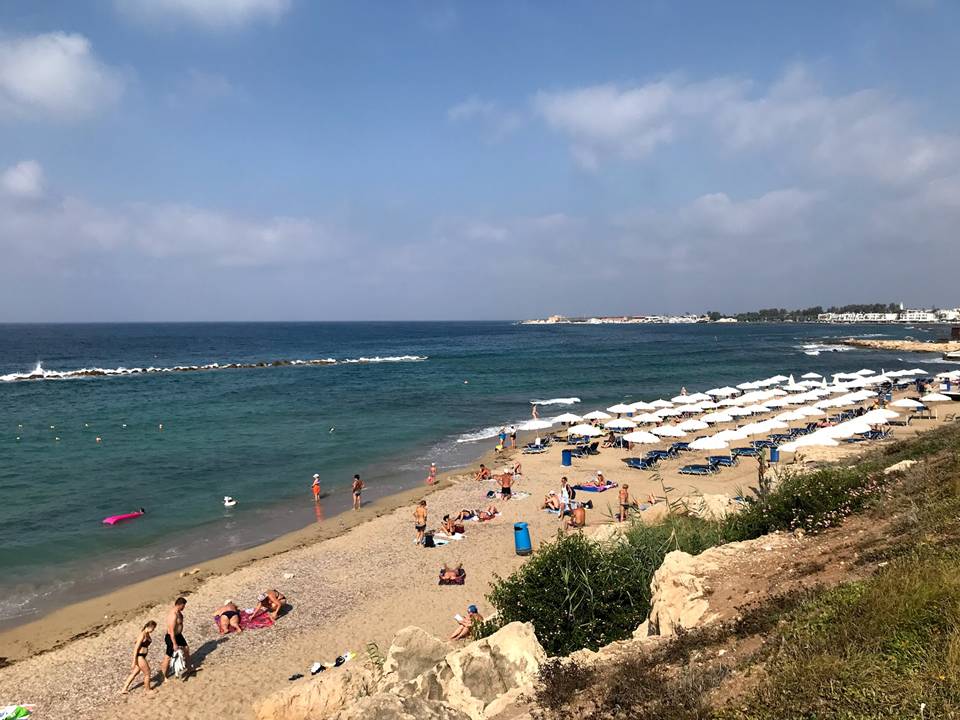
(396, 622, 546, 720)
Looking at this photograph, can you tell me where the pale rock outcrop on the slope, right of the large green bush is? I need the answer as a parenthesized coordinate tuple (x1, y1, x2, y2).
(634, 533, 797, 638)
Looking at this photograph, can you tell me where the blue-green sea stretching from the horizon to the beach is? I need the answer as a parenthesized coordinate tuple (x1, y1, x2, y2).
(0, 322, 957, 627)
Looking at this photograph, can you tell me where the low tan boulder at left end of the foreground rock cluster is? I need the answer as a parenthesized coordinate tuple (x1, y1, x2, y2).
(255, 663, 379, 720)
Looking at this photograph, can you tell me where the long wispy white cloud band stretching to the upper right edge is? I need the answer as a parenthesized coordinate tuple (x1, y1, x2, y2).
(533, 66, 960, 184)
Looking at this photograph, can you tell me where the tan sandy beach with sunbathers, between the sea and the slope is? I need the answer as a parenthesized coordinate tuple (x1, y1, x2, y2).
(0, 394, 945, 720)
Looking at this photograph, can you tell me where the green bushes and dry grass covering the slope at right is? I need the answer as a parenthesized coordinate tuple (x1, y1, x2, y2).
(502, 425, 960, 720)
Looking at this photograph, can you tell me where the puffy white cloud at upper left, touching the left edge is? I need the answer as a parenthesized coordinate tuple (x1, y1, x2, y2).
(0, 32, 124, 121)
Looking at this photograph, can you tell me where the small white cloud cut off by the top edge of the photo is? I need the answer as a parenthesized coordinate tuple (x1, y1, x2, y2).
(115, 0, 290, 30)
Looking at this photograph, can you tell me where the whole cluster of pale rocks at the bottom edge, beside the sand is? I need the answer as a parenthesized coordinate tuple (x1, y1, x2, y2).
(255, 623, 546, 720)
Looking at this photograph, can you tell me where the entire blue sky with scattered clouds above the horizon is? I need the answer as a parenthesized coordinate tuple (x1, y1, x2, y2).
(0, 0, 960, 322)
